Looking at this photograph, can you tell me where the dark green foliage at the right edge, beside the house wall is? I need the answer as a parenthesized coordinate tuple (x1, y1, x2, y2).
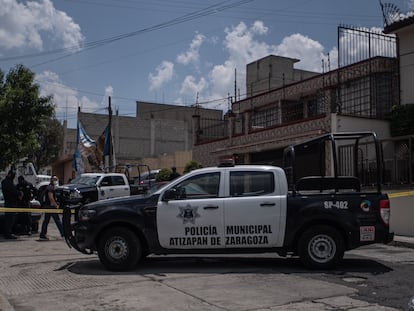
(390, 105, 414, 137)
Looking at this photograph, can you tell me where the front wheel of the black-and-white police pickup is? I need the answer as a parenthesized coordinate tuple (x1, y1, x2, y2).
(97, 227, 142, 271)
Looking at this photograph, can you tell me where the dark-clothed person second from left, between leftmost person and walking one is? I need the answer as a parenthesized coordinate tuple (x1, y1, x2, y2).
(17, 176, 36, 235)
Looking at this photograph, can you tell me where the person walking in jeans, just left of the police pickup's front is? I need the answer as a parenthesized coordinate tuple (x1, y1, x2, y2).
(39, 175, 64, 241)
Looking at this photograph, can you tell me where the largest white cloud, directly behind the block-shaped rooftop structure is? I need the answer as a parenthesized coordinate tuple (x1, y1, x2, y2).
(205, 21, 337, 105)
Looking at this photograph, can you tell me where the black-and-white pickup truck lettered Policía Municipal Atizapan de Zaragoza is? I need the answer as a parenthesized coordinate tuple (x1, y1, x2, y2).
(63, 133, 393, 271)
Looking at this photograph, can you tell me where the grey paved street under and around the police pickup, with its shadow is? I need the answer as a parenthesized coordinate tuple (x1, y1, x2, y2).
(0, 223, 414, 311)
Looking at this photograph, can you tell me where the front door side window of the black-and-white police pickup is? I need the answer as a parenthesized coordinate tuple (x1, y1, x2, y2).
(175, 172, 220, 200)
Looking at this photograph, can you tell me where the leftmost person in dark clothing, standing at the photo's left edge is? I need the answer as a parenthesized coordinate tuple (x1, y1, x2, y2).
(1, 170, 22, 239)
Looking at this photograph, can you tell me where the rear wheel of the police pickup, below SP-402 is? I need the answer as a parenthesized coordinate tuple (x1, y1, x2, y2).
(298, 225, 345, 269)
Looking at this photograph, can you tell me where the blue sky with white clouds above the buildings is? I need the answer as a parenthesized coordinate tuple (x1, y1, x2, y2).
(0, 0, 414, 127)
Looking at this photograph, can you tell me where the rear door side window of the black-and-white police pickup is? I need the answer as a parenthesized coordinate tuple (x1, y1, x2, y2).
(230, 171, 275, 197)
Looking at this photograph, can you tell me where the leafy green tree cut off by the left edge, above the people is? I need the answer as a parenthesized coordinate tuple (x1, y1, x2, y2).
(0, 65, 54, 169)
